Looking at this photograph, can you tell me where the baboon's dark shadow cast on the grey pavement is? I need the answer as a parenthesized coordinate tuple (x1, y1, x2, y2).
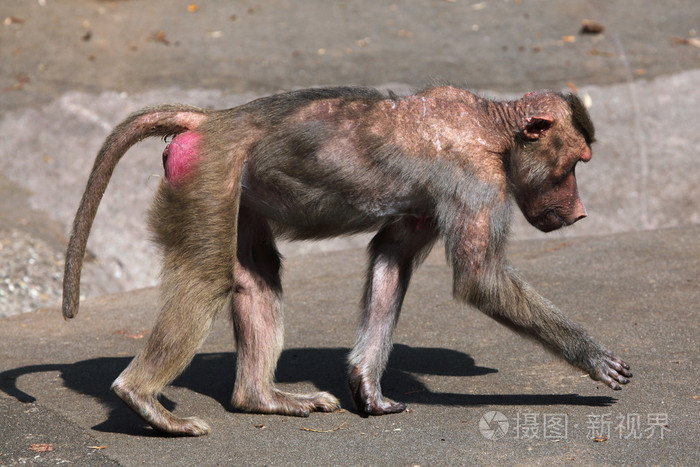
(0, 344, 616, 436)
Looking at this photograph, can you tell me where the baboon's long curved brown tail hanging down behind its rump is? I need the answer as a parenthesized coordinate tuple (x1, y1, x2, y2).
(63, 105, 207, 319)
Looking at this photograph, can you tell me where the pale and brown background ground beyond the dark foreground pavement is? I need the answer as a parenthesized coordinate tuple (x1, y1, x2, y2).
(0, 0, 700, 310)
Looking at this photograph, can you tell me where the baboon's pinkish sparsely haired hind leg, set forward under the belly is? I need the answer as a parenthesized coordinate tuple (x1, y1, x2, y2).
(232, 207, 340, 417)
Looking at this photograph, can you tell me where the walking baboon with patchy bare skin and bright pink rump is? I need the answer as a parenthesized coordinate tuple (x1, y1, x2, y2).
(63, 86, 632, 435)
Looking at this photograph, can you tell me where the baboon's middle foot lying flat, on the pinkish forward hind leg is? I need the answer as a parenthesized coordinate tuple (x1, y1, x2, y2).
(232, 389, 340, 417)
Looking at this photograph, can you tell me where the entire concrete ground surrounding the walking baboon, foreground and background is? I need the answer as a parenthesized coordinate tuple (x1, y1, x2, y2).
(0, 0, 700, 465)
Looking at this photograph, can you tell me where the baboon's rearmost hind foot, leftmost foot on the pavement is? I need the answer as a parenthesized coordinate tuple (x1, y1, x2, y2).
(112, 380, 210, 436)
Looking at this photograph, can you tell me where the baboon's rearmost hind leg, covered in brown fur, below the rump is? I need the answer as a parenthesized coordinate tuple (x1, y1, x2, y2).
(112, 185, 236, 436)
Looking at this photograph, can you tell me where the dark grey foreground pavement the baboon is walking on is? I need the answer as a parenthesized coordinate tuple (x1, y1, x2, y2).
(0, 227, 700, 465)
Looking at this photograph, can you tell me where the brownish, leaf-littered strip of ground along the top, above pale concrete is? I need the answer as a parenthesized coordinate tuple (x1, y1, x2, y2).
(0, 0, 700, 106)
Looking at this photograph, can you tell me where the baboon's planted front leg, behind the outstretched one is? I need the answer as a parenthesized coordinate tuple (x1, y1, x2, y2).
(349, 217, 437, 415)
